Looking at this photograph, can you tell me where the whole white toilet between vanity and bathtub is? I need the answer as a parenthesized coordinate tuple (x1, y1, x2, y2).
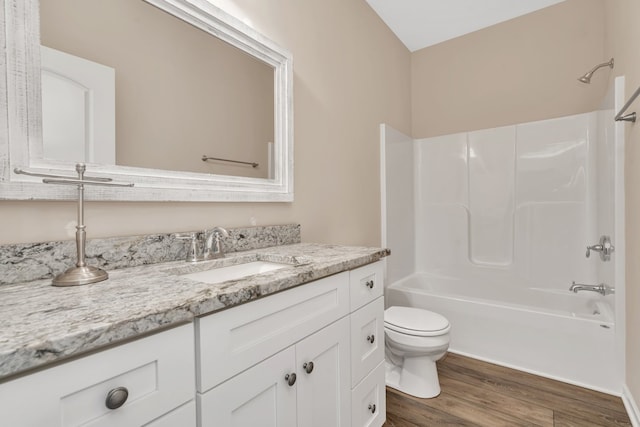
(384, 307, 451, 398)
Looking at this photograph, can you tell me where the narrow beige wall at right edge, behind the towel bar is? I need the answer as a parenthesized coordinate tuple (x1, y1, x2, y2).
(605, 0, 640, 412)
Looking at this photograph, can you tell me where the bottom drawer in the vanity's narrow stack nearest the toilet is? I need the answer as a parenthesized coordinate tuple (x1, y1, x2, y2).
(351, 362, 387, 427)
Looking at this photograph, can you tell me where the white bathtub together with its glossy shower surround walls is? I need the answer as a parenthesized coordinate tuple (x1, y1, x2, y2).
(383, 109, 623, 394)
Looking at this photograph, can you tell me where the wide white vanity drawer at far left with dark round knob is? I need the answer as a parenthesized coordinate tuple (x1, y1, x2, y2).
(0, 324, 195, 427)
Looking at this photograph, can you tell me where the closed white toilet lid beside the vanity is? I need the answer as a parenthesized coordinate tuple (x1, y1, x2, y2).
(384, 307, 449, 336)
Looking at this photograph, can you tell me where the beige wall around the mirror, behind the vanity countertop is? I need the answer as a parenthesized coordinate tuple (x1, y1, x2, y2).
(0, 0, 411, 245)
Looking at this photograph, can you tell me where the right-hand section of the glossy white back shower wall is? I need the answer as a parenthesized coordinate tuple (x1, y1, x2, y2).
(515, 113, 595, 289)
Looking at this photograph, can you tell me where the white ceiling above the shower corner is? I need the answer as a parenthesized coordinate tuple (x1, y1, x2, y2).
(367, 0, 564, 52)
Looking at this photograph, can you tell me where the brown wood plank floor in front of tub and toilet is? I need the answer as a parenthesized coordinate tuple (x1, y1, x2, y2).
(384, 353, 631, 427)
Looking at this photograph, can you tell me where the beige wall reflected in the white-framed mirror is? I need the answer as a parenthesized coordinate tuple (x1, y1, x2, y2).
(40, 0, 274, 178)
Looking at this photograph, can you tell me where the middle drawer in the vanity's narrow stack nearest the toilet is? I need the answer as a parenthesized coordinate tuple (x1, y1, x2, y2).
(351, 297, 384, 387)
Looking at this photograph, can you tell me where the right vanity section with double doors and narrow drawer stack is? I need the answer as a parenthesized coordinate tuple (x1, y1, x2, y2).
(196, 262, 386, 427)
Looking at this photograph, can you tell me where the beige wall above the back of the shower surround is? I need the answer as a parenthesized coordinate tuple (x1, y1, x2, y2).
(412, 0, 609, 138)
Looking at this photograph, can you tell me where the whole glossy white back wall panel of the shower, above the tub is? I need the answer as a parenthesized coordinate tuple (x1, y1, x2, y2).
(416, 113, 599, 289)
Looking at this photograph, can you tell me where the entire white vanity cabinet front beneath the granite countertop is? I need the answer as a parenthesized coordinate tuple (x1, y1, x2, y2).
(0, 262, 385, 427)
